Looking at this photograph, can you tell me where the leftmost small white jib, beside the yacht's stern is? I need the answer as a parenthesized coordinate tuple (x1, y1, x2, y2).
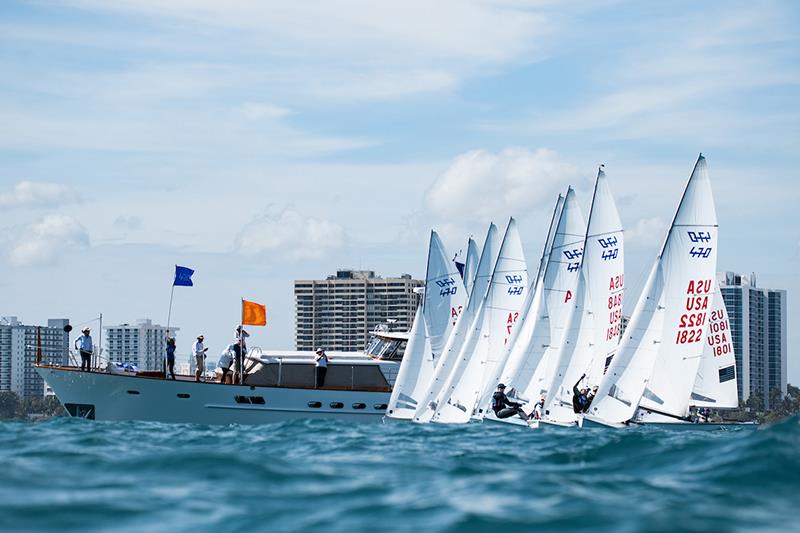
(386, 305, 434, 420)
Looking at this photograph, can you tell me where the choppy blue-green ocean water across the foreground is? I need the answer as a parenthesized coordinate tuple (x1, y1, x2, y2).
(0, 417, 800, 533)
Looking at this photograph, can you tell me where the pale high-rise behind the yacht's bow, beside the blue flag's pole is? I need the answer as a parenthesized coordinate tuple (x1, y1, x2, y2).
(104, 318, 180, 370)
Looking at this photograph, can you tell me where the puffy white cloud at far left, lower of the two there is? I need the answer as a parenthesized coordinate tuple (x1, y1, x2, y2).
(8, 214, 89, 266)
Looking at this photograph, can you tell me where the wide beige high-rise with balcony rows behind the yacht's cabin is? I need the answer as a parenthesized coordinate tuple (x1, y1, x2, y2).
(294, 270, 425, 352)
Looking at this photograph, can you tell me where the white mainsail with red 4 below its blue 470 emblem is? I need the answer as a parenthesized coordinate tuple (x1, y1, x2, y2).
(510, 187, 586, 401)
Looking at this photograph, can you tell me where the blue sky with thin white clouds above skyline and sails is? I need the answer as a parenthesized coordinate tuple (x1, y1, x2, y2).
(0, 0, 800, 383)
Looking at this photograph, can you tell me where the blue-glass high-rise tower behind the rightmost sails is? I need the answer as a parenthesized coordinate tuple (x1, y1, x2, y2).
(717, 272, 788, 409)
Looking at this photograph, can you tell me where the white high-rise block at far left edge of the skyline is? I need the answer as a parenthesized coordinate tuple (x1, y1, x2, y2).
(0, 316, 69, 398)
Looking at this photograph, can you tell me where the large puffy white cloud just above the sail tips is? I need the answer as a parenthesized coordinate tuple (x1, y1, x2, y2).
(426, 148, 578, 222)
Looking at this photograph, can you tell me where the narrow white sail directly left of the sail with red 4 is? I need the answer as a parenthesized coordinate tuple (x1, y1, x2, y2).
(496, 194, 564, 394)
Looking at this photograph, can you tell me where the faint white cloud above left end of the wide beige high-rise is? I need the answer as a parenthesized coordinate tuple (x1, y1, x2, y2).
(235, 209, 345, 259)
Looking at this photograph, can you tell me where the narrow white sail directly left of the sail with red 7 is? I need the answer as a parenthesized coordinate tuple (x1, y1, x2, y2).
(414, 224, 500, 423)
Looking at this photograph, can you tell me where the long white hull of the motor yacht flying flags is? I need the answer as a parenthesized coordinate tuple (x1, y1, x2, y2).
(37, 367, 390, 424)
